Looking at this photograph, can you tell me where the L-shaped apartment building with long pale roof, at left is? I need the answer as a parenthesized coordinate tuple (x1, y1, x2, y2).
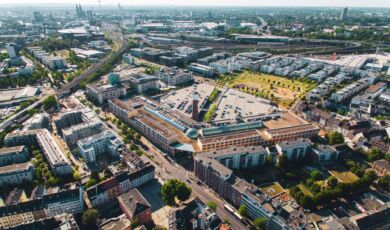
(4, 129, 72, 175)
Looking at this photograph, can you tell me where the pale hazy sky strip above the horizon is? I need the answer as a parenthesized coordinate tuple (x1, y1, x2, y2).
(0, 0, 390, 7)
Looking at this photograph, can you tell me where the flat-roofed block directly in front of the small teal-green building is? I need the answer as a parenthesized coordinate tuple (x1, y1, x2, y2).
(87, 83, 126, 104)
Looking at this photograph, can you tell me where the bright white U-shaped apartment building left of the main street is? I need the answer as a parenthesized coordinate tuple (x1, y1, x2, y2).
(77, 130, 124, 162)
